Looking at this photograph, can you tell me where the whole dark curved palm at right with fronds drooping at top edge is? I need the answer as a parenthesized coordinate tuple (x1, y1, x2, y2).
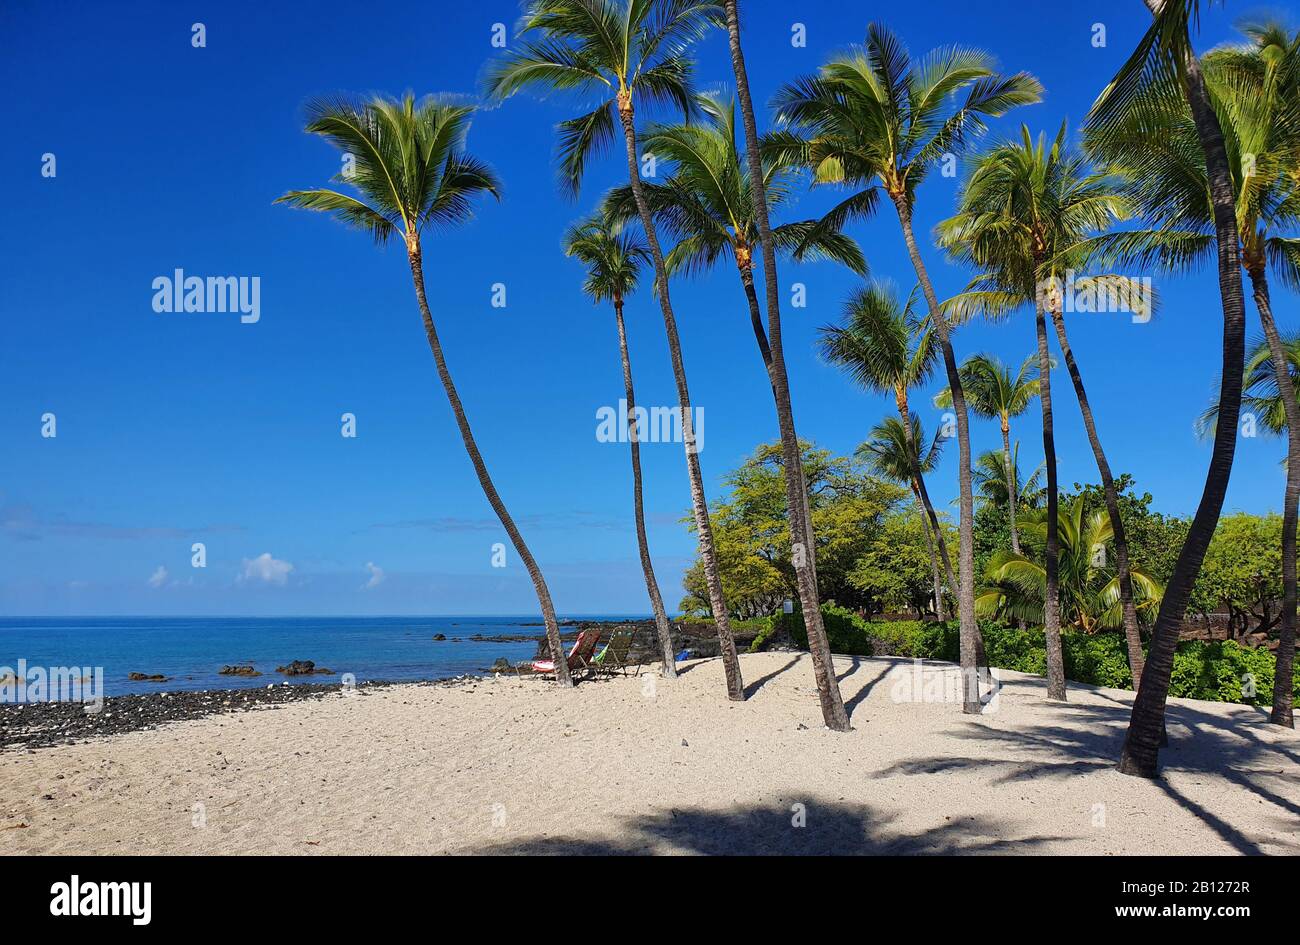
(1089, 0, 1245, 777)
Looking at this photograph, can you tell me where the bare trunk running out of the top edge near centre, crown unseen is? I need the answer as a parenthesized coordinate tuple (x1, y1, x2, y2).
(725, 0, 849, 732)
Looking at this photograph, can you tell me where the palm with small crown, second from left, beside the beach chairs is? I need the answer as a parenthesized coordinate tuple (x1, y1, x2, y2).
(564, 217, 677, 679)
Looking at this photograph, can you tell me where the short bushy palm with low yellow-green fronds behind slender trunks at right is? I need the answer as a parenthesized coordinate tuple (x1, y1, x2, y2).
(975, 497, 1161, 633)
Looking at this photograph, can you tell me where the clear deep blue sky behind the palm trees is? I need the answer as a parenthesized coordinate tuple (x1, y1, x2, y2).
(0, 0, 1295, 615)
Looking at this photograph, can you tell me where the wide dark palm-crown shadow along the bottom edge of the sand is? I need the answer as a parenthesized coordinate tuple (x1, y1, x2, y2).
(471, 798, 1057, 857)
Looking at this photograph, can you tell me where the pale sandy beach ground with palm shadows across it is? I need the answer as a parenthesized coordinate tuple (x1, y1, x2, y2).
(0, 654, 1300, 854)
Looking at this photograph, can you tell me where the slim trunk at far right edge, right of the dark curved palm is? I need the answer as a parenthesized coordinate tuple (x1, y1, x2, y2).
(1248, 266, 1300, 728)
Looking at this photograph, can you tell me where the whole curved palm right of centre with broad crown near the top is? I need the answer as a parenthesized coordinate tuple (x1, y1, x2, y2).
(777, 23, 1043, 714)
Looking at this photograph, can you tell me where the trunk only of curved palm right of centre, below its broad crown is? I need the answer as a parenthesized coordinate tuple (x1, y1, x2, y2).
(894, 196, 984, 715)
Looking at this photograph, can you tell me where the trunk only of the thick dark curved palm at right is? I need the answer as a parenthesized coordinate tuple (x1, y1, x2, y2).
(1119, 9, 1245, 777)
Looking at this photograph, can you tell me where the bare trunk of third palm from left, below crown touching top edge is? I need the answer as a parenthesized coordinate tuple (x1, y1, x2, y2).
(618, 90, 745, 702)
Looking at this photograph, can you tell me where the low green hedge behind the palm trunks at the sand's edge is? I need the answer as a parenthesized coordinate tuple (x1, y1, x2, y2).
(750, 603, 1300, 706)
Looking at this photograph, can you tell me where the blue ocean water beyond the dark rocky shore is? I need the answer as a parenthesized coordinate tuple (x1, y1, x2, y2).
(0, 615, 625, 695)
